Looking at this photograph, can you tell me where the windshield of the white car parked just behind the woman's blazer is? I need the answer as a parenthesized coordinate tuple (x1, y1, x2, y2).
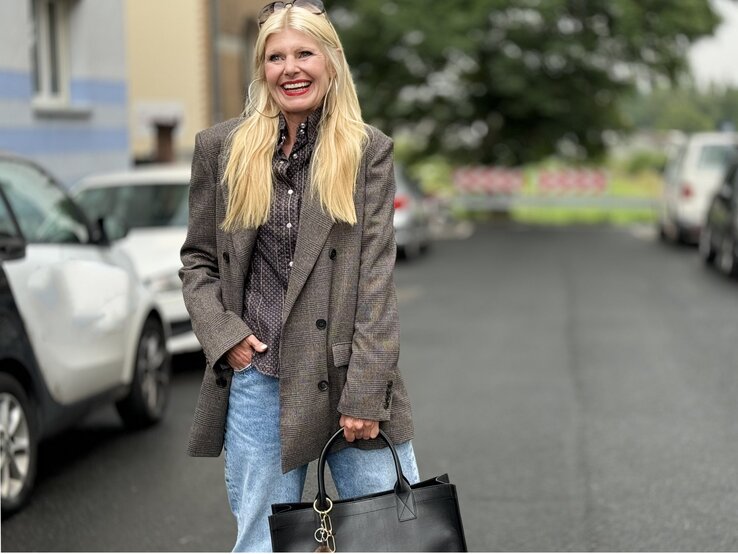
(77, 183, 188, 229)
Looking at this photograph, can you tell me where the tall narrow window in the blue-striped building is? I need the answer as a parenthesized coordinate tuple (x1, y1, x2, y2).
(30, 0, 70, 104)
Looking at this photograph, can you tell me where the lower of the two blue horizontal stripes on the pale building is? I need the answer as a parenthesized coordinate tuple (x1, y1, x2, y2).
(0, 127, 128, 156)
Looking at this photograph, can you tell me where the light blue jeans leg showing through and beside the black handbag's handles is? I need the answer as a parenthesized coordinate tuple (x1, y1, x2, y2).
(328, 441, 420, 499)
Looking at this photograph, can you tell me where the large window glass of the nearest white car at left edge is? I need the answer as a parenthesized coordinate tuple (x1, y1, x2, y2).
(0, 160, 89, 243)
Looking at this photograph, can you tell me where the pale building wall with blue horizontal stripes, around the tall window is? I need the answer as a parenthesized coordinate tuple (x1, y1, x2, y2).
(0, 0, 130, 185)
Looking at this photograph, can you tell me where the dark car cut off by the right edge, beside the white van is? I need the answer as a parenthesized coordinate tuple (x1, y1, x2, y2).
(699, 148, 738, 277)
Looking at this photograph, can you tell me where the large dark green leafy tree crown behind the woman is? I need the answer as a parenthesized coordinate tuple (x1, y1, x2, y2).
(328, 0, 719, 165)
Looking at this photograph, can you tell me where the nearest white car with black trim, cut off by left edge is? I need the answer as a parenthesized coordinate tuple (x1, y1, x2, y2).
(0, 154, 170, 517)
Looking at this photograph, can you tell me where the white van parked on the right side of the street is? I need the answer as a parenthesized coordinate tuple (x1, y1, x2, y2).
(659, 132, 738, 244)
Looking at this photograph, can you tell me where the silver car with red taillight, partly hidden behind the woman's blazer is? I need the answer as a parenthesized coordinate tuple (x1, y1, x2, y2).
(394, 164, 431, 259)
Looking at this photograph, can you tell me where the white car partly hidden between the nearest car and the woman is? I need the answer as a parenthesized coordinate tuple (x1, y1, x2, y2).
(72, 165, 201, 354)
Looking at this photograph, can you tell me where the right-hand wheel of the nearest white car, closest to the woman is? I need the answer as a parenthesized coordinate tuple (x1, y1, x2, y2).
(116, 317, 171, 429)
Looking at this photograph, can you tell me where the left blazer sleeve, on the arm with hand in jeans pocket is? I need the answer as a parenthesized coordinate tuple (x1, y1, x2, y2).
(179, 133, 252, 370)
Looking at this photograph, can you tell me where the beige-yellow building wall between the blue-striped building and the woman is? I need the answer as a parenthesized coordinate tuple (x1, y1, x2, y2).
(126, 0, 212, 161)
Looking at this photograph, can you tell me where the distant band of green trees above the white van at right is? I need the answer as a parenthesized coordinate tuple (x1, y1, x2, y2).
(623, 85, 738, 133)
